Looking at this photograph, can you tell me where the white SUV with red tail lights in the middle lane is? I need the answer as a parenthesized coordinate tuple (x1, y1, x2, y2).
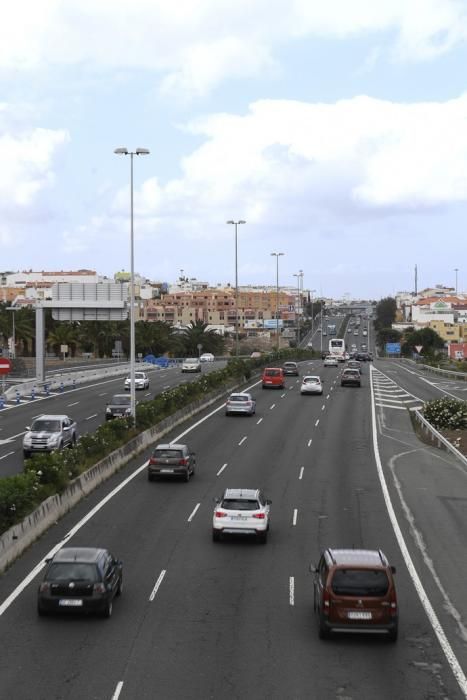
(212, 489, 271, 544)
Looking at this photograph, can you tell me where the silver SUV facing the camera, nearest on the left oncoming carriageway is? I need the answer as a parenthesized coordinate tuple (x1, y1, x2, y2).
(23, 414, 78, 459)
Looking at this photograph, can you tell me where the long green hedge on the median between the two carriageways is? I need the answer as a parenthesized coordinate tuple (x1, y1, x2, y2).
(0, 349, 312, 534)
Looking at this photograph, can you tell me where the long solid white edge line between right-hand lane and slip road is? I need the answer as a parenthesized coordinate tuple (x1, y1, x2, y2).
(370, 368, 467, 698)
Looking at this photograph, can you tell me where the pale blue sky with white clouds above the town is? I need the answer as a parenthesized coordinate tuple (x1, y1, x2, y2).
(0, 0, 467, 299)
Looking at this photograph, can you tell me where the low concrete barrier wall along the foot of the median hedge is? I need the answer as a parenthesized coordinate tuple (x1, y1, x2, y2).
(0, 385, 235, 573)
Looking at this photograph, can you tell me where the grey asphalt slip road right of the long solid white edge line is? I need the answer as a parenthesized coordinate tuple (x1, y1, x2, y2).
(379, 396, 467, 688)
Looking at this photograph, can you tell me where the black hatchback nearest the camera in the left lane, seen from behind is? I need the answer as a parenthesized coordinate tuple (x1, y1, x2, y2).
(37, 547, 123, 617)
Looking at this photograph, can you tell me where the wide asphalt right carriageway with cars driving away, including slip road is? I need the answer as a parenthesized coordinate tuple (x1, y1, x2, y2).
(0, 326, 467, 700)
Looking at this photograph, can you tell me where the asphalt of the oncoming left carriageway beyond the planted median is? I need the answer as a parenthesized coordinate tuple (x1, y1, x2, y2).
(0, 360, 225, 478)
